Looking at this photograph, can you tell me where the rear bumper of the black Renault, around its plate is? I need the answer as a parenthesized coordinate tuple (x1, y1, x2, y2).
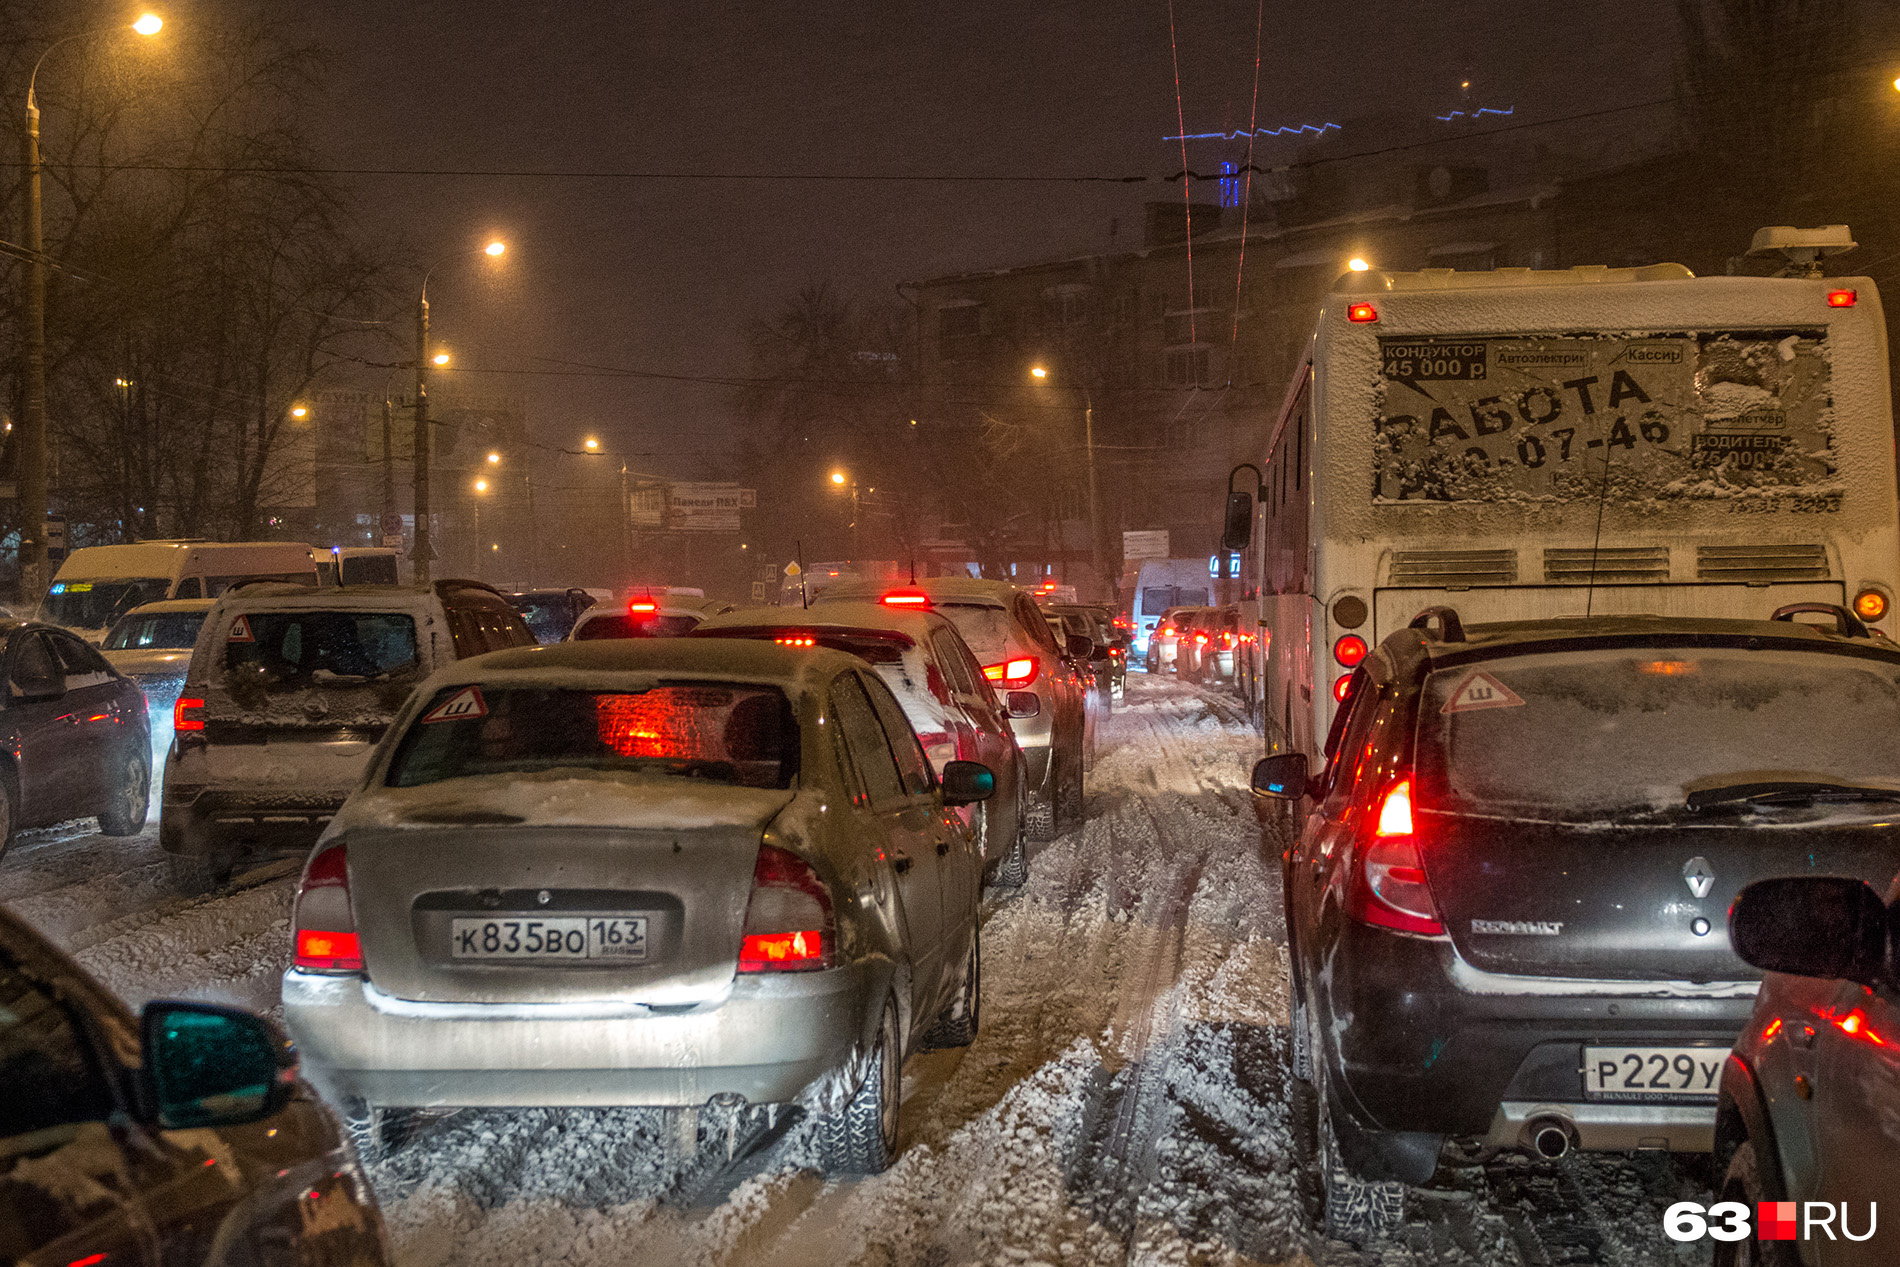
(1324, 925, 1756, 1151)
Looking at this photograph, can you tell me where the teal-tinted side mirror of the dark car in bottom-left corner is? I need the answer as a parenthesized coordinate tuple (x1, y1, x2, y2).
(139, 999, 296, 1130)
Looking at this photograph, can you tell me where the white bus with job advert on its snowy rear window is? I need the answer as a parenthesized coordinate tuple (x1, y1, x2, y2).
(1229, 252, 1900, 754)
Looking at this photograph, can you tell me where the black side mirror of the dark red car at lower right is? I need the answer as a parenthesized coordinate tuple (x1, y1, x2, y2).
(1729, 876, 1889, 986)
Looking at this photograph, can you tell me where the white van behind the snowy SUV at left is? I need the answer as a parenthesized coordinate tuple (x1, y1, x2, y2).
(40, 541, 317, 642)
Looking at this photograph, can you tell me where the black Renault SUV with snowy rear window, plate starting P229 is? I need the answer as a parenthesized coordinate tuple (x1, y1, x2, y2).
(1254, 604, 1900, 1240)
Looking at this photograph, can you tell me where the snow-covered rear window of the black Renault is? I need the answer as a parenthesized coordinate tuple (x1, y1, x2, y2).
(1417, 648, 1900, 821)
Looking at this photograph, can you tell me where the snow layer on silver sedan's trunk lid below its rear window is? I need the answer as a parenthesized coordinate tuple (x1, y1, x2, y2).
(325, 769, 794, 836)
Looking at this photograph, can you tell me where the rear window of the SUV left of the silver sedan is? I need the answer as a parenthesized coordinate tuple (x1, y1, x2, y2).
(224, 612, 418, 693)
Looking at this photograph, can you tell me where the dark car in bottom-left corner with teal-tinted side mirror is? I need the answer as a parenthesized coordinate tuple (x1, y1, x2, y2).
(0, 912, 388, 1267)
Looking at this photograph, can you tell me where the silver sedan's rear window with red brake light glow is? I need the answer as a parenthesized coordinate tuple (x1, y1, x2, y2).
(388, 684, 798, 788)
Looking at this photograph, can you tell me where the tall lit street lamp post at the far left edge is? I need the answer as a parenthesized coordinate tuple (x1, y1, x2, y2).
(19, 13, 165, 602)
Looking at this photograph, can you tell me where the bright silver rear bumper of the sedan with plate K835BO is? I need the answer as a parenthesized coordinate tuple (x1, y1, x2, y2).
(283, 965, 880, 1107)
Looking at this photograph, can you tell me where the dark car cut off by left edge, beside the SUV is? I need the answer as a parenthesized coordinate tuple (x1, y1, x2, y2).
(0, 621, 152, 851)
